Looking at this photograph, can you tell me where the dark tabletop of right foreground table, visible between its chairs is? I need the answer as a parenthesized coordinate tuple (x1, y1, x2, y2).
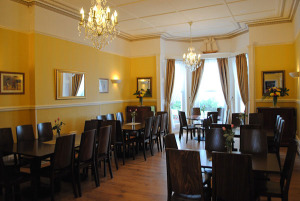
(199, 150, 280, 173)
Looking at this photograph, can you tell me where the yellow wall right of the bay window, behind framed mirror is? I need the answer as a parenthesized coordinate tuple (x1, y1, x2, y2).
(255, 44, 297, 107)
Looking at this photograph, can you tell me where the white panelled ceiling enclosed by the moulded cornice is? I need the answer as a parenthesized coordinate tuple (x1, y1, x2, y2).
(41, 0, 299, 39)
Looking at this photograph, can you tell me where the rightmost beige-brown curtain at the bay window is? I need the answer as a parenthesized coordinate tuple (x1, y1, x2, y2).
(235, 54, 249, 118)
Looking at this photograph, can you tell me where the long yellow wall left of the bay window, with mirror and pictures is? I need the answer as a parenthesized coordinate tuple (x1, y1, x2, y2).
(0, 29, 157, 138)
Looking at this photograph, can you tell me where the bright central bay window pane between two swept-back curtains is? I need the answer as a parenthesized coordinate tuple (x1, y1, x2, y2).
(194, 59, 225, 114)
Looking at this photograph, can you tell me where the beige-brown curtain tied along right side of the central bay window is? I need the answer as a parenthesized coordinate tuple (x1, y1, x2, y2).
(217, 58, 232, 124)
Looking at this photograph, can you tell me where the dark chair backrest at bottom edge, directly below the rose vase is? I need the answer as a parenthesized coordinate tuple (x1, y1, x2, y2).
(212, 152, 255, 201)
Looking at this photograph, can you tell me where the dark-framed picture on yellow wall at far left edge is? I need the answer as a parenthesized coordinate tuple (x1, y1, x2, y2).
(0, 71, 25, 94)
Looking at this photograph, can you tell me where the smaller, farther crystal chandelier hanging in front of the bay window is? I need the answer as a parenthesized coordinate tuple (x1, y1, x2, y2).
(183, 22, 201, 71)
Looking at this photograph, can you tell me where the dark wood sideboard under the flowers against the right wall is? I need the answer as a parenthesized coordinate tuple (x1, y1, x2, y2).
(257, 107, 297, 146)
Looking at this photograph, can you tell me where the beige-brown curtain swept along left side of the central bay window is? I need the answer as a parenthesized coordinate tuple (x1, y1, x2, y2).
(188, 59, 205, 114)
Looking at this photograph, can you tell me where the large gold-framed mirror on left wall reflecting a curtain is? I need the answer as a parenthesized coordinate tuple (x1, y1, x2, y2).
(56, 70, 86, 99)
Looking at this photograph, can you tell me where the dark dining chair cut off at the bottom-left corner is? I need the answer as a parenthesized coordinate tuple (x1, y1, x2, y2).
(0, 151, 31, 201)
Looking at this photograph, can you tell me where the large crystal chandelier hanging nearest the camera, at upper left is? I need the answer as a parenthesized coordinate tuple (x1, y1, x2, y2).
(78, 0, 119, 50)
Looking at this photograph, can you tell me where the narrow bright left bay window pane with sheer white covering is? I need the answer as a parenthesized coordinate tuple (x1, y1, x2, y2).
(171, 61, 187, 132)
